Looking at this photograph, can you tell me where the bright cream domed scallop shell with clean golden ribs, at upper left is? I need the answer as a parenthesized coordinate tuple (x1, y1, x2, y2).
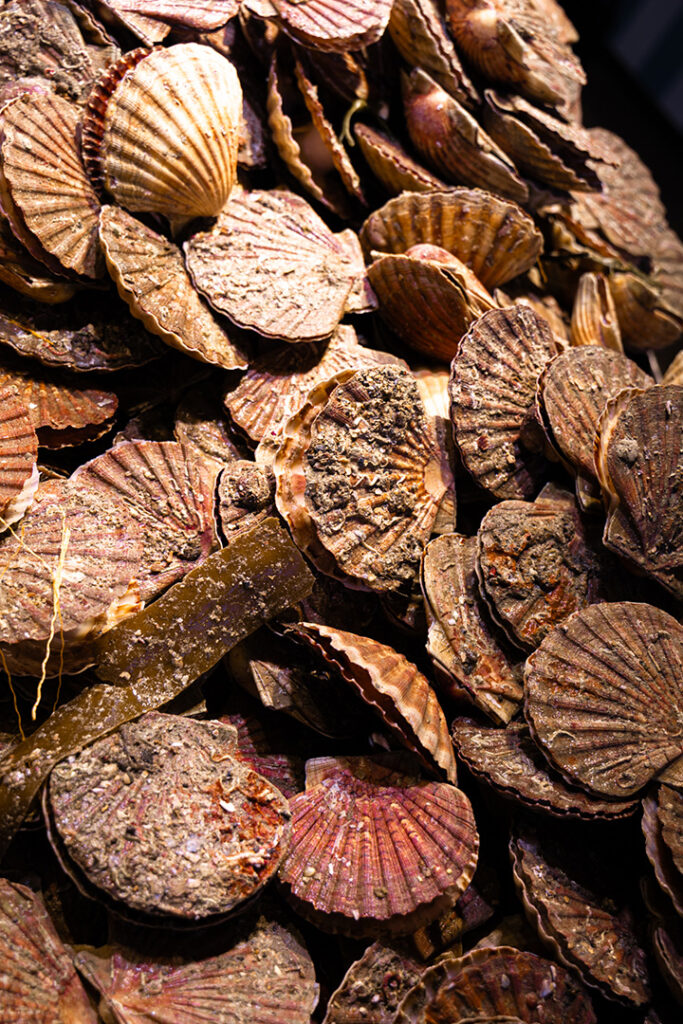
(82, 43, 242, 219)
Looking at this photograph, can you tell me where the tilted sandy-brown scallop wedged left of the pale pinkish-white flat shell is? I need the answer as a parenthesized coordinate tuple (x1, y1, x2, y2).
(99, 206, 246, 370)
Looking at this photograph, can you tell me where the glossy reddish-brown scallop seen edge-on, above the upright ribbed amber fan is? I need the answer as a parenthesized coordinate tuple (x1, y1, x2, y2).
(402, 68, 528, 203)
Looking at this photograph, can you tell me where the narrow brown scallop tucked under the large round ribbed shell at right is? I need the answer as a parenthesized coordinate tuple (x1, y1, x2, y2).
(453, 718, 638, 821)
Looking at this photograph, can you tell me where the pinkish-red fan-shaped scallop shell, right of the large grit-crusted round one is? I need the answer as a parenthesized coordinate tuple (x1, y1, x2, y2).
(280, 758, 478, 934)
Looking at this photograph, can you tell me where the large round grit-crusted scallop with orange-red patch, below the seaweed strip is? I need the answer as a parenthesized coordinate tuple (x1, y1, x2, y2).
(48, 712, 290, 923)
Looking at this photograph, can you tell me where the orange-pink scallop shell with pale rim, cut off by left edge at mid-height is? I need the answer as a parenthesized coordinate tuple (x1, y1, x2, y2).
(0, 385, 38, 534)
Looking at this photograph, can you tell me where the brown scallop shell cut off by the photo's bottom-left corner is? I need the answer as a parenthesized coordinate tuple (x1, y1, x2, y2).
(0, 879, 97, 1024)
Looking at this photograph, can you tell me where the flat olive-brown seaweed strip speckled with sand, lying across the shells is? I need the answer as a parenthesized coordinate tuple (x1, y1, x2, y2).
(0, 518, 313, 856)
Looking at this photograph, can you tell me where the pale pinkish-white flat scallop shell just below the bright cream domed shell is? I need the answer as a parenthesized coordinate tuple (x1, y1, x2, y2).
(184, 190, 365, 342)
